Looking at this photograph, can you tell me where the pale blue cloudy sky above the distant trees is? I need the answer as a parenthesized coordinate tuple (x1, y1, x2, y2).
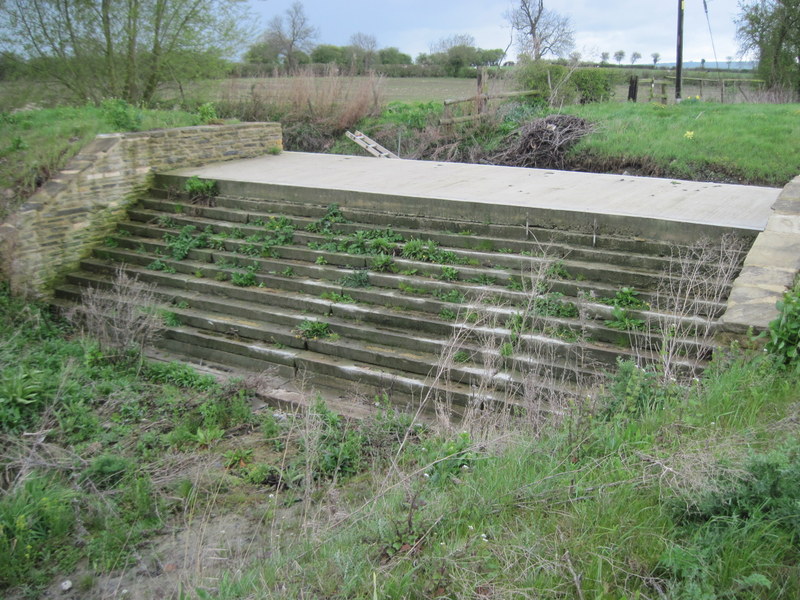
(250, 0, 739, 63)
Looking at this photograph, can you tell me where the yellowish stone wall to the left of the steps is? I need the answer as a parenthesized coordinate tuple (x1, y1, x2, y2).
(0, 123, 282, 297)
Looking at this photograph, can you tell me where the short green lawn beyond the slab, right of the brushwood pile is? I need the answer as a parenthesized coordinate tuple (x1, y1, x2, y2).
(564, 101, 800, 186)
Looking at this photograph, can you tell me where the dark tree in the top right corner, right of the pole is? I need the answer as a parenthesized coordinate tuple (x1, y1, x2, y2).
(736, 0, 800, 92)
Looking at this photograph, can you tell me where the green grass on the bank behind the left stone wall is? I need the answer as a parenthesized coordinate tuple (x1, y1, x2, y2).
(0, 106, 198, 220)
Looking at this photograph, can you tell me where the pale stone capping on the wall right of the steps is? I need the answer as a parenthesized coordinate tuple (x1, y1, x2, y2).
(720, 176, 800, 335)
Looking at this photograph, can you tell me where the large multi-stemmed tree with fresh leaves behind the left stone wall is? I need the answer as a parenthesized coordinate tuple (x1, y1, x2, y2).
(0, 0, 247, 104)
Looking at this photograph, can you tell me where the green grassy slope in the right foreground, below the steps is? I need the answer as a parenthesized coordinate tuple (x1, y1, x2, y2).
(205, 359, 800, 600)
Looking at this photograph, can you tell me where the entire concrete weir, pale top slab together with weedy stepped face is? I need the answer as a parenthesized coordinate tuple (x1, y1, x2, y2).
(54, 152, 800, 410)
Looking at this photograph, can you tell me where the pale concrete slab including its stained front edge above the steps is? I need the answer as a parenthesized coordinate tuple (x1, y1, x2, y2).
(170, 152, 780, 243)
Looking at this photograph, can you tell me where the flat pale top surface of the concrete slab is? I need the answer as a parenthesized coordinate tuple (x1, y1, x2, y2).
(169, 152, 781, 231)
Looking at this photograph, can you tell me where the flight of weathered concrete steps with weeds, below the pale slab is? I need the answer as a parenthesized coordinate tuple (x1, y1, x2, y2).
(54, 177, 744, 412)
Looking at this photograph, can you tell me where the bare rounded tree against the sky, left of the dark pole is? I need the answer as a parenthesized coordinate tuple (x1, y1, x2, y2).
(507, 0, 575, 60)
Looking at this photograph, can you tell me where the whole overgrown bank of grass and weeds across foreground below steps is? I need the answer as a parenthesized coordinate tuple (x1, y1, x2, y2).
(0, 278, 800, 600)
